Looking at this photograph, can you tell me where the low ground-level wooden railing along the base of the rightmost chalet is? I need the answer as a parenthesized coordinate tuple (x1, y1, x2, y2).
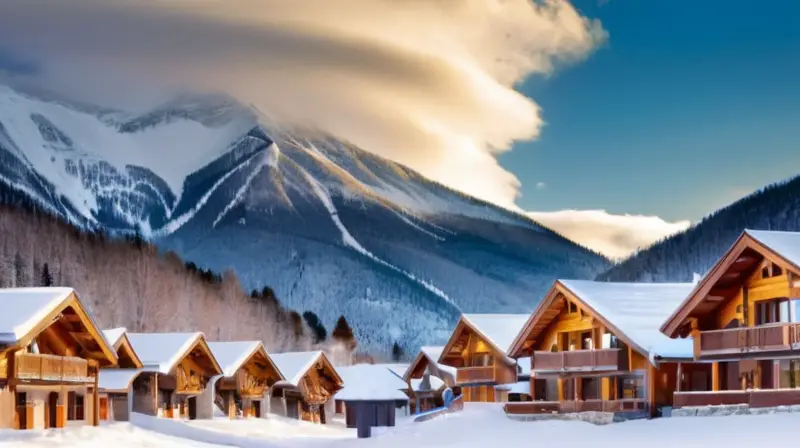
(673, 389, 800, 408)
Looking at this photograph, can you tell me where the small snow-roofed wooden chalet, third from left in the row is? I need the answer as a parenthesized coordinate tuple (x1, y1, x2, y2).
(127, 333, 223, 419)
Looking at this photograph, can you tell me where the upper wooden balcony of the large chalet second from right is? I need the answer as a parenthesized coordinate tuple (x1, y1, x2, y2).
(531, 348, 628, 372)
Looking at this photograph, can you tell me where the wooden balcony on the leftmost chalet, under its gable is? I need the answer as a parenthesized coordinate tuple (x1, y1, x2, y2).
(15, 353, 94, 383)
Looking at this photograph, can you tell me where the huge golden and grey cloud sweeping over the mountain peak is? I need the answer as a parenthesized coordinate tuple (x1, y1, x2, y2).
(0, 0, 606, 208)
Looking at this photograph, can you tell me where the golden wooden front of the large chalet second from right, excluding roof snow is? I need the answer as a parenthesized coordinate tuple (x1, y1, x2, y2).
(506, 281, 700, 416)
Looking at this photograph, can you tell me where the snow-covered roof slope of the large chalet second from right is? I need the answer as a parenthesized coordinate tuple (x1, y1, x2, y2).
(559, 280, 694, 358)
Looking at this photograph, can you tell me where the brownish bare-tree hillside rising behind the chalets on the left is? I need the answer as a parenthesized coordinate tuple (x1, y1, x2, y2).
(0, 187, 314, 351)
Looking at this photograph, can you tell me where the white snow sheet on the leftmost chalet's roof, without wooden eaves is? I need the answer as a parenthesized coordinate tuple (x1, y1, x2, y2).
(0, 288, 75, 344)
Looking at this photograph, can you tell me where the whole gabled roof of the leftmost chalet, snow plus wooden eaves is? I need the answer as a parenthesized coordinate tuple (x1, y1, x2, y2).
(0, 287, 117, 365)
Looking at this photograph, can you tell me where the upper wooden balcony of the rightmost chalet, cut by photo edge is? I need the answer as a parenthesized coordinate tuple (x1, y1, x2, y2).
(695, 323, 800, 359)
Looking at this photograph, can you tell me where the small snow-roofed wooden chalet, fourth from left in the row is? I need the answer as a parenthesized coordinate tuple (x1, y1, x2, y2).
(206, 341, 285, 419)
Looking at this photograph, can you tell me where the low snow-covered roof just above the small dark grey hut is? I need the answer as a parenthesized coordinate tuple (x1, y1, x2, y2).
(335, 364, 408, 401)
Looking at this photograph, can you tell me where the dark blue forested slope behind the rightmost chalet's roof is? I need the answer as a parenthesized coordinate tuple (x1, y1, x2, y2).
(598, 177, 800, 282)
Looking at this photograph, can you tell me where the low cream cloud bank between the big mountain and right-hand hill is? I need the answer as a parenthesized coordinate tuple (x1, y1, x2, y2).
(527, 210, 691, 259)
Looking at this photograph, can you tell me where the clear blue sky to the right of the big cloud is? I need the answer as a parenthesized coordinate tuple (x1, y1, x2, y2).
(500, 0, 800, 221)
